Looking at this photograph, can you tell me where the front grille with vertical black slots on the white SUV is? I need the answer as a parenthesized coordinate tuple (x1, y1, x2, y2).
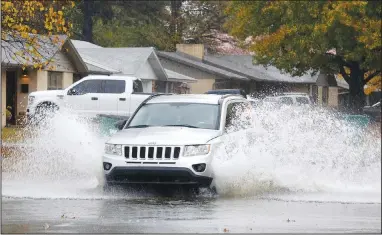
(124, 146, 181, 160)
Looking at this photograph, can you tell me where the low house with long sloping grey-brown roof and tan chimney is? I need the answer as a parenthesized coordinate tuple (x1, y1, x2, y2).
(157, 44, 348, 107)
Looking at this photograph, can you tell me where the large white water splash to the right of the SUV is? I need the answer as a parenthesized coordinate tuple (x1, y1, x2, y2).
(213, 105, 381, 202)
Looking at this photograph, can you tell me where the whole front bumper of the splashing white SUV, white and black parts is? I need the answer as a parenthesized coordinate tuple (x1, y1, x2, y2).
(103, 153, 214, 187)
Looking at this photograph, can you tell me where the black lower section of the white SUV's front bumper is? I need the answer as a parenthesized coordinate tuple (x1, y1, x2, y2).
(105, 166, 212, 187)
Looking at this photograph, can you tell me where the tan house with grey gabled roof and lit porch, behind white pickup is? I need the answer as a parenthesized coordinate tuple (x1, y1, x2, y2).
(1, 35, 196, 126)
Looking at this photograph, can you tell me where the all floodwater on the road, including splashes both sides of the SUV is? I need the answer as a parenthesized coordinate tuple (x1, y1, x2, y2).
(2, 110, 381, 233)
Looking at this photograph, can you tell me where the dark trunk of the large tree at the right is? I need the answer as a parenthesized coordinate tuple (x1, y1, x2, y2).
(348, 64, 366, 114)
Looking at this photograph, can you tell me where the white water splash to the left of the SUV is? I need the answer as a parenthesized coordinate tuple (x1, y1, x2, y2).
(3, 112, 105, 197)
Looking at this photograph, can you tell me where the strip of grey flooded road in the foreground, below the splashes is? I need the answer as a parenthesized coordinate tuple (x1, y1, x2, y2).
(2, 193, 381, 233)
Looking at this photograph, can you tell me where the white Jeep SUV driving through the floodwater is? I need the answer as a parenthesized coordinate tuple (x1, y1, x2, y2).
(103, 94, 252, 194)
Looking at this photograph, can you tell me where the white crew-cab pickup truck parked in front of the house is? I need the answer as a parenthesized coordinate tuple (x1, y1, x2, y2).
(27, 75, 155, 120)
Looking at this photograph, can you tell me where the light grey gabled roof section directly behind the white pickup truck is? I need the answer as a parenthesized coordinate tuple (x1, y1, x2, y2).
(72, 40, 196, 92)
